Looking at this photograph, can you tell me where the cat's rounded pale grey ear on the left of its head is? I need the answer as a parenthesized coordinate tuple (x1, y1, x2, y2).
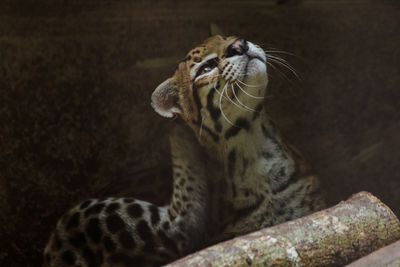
(151, 78, 181, 118)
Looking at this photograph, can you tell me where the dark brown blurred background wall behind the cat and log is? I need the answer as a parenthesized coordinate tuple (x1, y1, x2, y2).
(0, 0, 400, 266)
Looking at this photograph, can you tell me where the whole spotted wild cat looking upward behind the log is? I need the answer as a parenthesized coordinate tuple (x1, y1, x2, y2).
(44, 36, 324, 266)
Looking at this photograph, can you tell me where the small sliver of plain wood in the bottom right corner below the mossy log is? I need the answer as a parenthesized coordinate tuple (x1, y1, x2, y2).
(346, 241, 400, 267)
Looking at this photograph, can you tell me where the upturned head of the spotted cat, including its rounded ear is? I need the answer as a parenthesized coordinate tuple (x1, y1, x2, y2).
(152, 35, 268, 147)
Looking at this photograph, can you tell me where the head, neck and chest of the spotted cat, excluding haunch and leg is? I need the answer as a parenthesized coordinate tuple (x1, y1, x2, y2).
(152, 36, 324, 244)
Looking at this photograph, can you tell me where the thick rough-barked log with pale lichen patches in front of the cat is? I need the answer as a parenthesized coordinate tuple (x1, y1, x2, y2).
(167, 192, 400, 267)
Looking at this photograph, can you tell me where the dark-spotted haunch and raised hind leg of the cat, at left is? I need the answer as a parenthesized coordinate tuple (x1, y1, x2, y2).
(44, 128, 208, 267)
